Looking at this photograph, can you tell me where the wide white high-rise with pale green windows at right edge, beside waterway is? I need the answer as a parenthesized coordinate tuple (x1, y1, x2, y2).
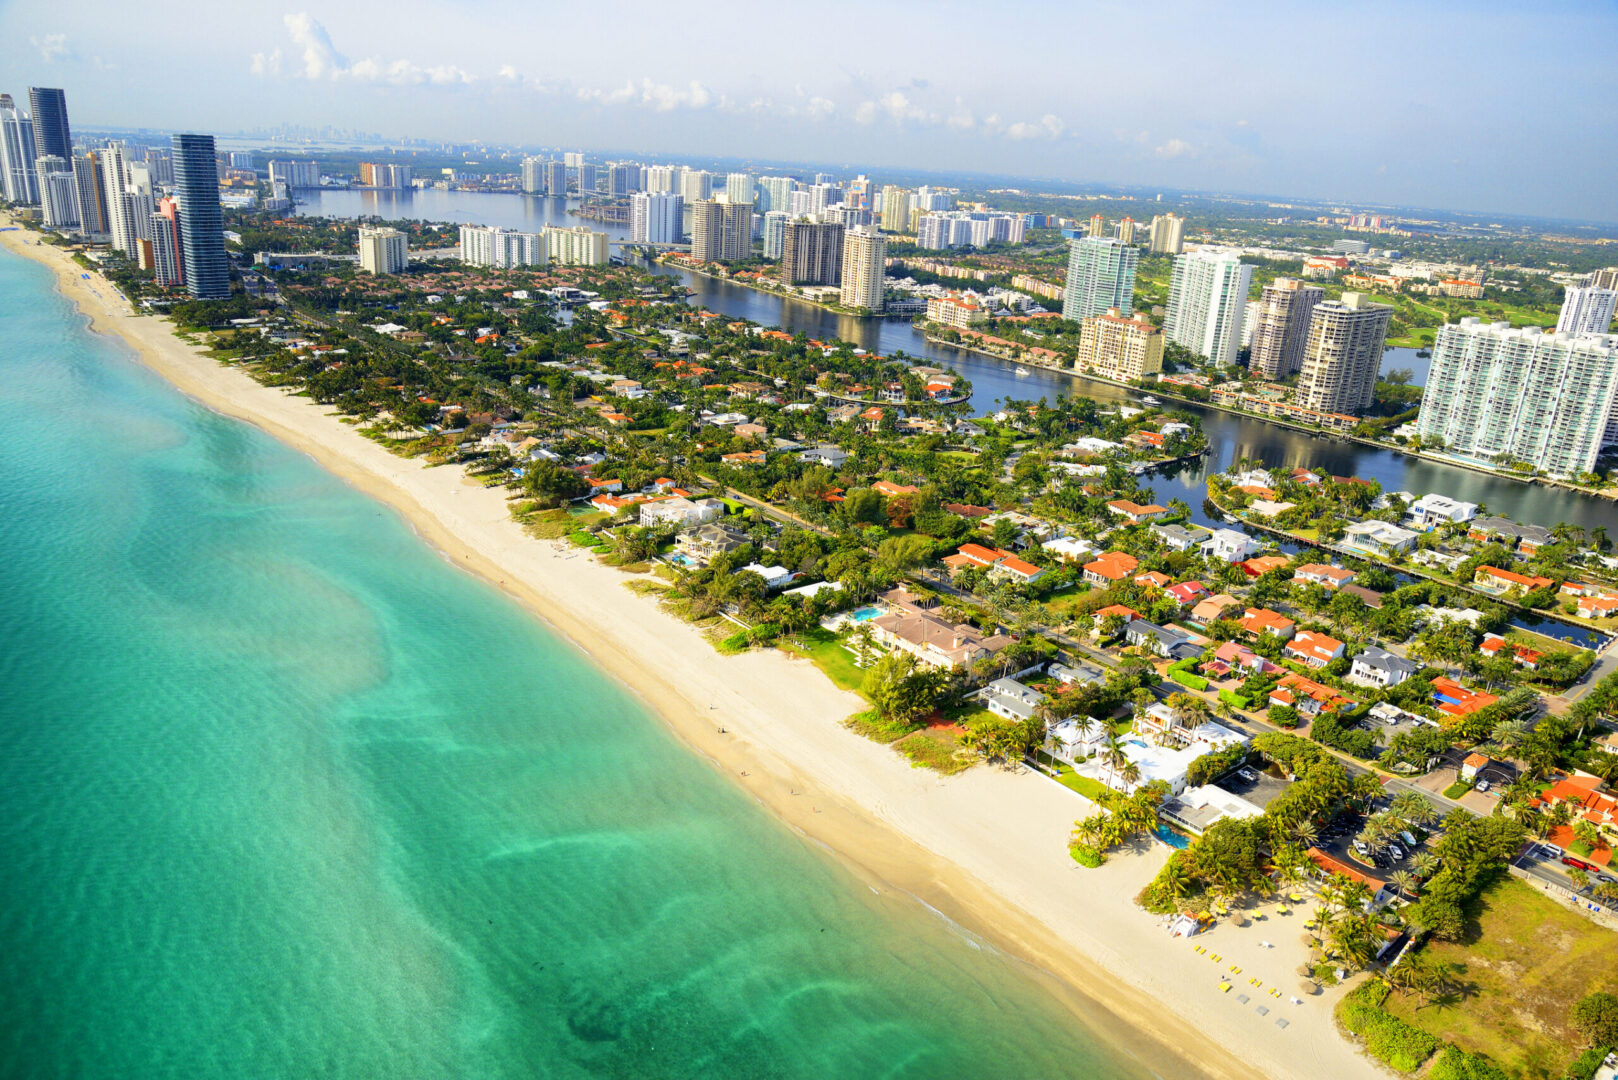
(1416, 317, 1618, 476)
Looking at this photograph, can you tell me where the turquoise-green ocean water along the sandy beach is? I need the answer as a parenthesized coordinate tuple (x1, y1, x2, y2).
(0, 249, 1146, 1078)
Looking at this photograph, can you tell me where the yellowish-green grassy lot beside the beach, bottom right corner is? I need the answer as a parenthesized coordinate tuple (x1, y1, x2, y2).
(1383, 878, 1618, 1080)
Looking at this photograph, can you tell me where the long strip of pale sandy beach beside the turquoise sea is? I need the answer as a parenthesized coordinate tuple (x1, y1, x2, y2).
(0, 221, 1382, 1077)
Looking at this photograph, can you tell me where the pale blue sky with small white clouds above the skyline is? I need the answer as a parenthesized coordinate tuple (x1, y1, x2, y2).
(0, 0, 1618, 222)
